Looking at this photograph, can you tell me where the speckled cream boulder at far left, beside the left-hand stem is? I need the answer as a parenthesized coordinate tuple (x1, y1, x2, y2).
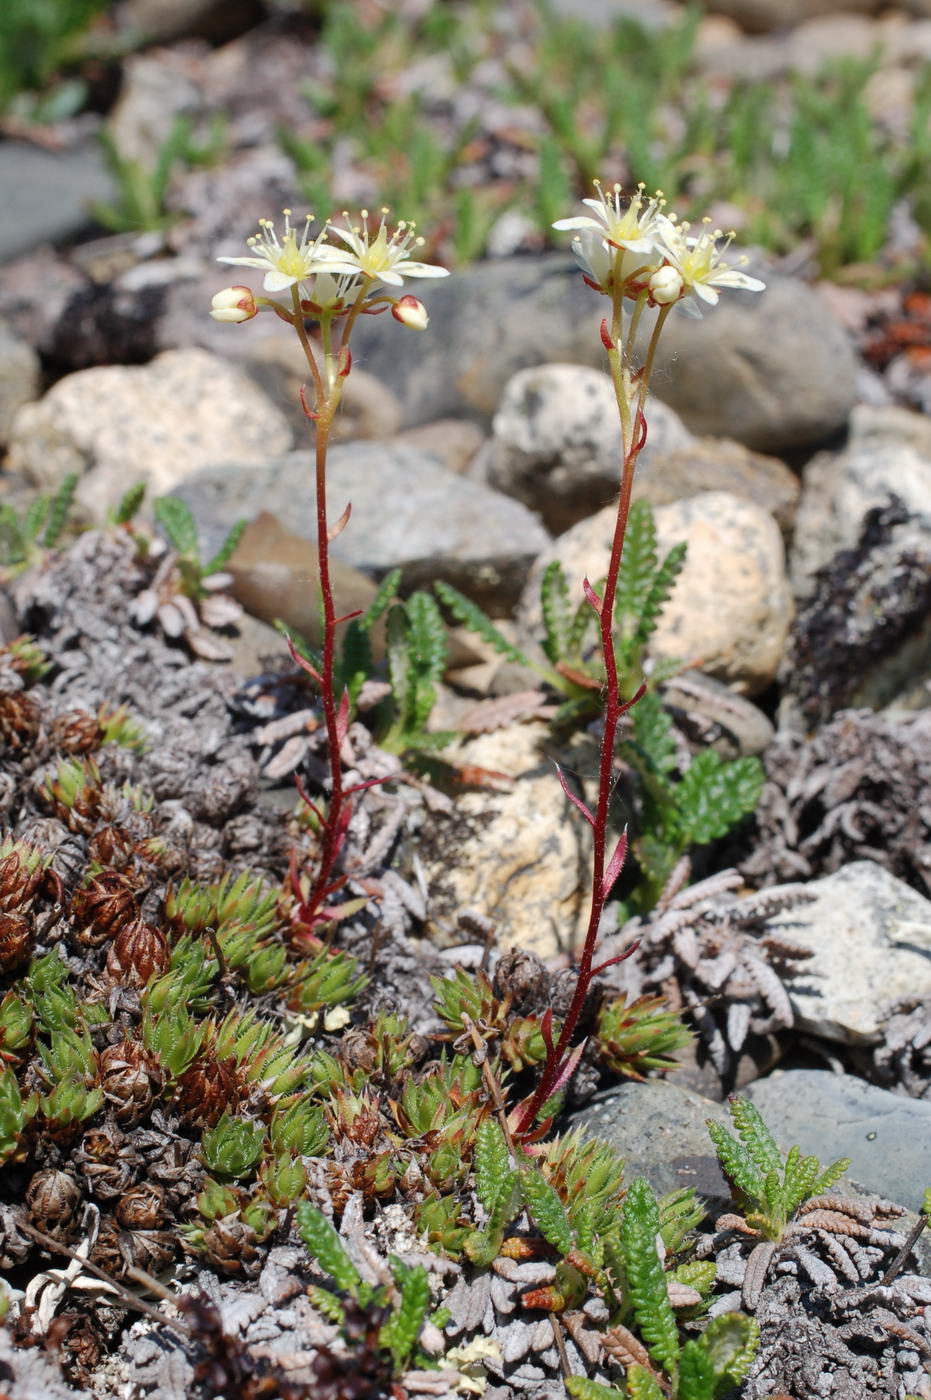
(10, 350, 291, 519)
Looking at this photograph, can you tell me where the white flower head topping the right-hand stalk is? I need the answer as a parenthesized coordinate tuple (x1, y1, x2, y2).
(553, 182, 764, 315)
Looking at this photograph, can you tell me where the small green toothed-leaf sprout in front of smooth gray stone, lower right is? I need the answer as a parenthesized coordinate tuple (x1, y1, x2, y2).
(708, 1095, 850, 1240)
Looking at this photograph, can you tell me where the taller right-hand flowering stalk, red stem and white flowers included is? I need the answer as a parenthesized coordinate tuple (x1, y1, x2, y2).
(511, 186, 763, 1141)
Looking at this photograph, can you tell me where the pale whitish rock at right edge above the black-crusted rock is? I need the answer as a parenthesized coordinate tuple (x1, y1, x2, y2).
(790, 436, 931, 598)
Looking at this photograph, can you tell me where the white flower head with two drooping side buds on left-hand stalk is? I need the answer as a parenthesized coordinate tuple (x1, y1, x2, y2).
(210, 209, 448, 330)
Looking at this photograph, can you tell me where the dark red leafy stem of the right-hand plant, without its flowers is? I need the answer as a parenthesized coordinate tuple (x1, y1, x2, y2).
(512, 289, 669, 1141)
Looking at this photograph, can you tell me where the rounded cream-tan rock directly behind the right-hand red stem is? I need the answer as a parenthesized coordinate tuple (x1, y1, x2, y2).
(518, 491, 792, 694)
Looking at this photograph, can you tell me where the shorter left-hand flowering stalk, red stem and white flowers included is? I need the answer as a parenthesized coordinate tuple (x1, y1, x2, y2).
(211, 210, 447, 939)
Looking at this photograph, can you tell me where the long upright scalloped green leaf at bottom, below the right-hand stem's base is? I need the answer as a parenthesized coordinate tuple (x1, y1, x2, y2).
(620, 1176, 679, 1373)
